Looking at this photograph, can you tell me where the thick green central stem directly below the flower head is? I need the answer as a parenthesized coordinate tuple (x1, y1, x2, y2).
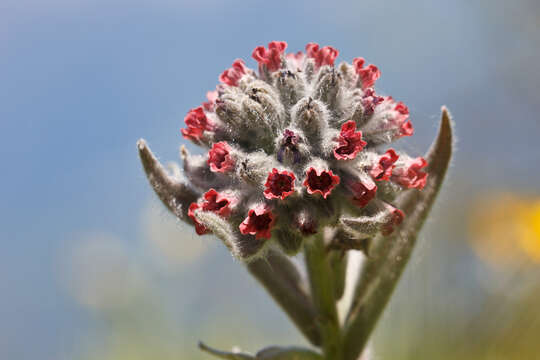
(304, 235, 343, 360)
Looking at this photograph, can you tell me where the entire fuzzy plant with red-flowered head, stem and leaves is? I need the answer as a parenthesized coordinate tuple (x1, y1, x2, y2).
(138, 41, 452, 360)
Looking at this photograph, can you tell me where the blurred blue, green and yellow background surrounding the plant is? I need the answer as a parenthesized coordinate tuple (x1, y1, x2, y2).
(0, 0, 540, 360)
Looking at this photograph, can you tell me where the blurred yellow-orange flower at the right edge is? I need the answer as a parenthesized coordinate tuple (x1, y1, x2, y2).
(469, 193, 540, 266)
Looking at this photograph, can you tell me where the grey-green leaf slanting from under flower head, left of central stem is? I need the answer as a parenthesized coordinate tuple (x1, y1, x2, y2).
(246, 250, 321, 346)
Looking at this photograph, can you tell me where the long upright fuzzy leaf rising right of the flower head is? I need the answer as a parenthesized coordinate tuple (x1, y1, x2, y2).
(344, 107, 453, 360)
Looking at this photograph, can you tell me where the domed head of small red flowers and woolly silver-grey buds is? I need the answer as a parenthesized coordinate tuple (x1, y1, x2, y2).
(171, 41, 427, 260)
